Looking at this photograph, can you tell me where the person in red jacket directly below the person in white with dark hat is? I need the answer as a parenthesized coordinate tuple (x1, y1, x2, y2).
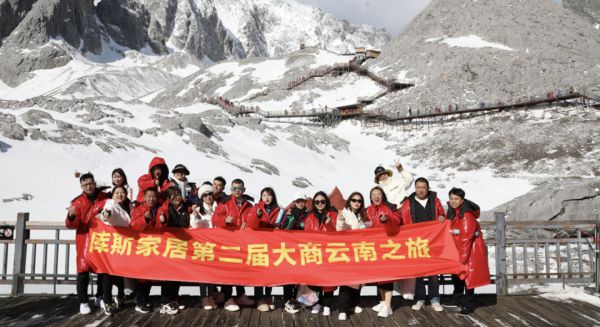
(367, 186, 400, 318)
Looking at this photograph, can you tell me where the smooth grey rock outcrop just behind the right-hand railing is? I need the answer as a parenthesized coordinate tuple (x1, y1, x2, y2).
(484, 178, 600, 221)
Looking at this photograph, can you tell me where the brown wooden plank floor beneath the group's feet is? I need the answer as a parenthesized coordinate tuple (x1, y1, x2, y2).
(0, 295, 600, 327)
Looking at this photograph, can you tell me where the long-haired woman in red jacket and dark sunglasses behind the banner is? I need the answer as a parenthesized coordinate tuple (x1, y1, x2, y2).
(304, 191, 337, 316)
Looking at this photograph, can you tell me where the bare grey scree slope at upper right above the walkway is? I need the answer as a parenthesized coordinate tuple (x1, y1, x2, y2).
(367, 0, 600, 112)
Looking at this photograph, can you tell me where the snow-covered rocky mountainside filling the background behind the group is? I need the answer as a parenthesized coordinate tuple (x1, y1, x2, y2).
(0, 0, 600, 226)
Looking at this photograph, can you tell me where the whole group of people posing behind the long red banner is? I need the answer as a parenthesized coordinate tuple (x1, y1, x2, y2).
(65, 157, 489, 320)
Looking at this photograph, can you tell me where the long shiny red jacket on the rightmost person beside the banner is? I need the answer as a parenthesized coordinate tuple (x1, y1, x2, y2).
(447, 200, 490, 289)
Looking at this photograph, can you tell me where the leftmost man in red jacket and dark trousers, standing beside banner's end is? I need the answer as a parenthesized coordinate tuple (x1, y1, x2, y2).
(65, 173, 106, 314)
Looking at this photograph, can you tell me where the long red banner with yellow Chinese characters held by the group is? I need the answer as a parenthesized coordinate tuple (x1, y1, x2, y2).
(86, 222, 465, 286)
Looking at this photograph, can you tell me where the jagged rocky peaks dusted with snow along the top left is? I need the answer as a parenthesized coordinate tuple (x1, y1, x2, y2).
(0, 0, 389, 86)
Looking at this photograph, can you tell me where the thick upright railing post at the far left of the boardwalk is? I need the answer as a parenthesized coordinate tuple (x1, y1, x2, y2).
(10, 212, 29, 296)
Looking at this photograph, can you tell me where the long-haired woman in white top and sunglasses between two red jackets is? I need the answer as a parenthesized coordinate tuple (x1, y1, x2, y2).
(335, 192, 372, 320)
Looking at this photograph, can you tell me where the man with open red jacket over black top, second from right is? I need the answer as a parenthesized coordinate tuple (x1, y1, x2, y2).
(400, 177, 446, 312)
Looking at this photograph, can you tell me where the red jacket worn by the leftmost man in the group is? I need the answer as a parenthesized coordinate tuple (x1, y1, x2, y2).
(65, 192, 106, 273)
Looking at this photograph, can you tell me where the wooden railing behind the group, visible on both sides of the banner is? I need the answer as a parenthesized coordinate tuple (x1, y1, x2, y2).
(0, 212, 600, 296)
